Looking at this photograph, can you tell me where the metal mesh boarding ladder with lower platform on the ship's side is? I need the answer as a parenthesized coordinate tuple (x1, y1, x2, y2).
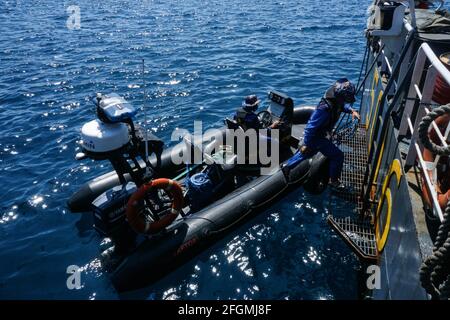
(327, 116, 378, 261)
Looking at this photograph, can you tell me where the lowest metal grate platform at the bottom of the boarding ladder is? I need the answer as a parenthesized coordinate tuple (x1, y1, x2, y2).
(327, 215, 378, 260)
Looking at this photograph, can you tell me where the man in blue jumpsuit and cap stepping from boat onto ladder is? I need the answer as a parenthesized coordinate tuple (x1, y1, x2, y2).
(288, 78, 360, 191)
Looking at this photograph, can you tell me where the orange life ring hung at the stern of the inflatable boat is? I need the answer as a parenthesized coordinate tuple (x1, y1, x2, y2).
(126, 178, 183, 234)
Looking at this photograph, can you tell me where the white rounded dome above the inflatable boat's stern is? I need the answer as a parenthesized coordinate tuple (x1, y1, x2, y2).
(81, 120, 130, 152)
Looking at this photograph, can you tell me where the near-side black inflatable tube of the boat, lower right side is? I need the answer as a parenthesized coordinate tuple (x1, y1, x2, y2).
(111, 153, 328, 292)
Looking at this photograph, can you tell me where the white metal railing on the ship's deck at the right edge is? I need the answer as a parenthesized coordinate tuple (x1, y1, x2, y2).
(399, 43, 450, 221)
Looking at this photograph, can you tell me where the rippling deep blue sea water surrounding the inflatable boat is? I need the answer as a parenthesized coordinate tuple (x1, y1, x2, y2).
(0, 0, 369, 299)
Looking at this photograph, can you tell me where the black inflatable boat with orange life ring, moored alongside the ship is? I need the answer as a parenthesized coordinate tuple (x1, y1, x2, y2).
(68, 91, 329, 292)
